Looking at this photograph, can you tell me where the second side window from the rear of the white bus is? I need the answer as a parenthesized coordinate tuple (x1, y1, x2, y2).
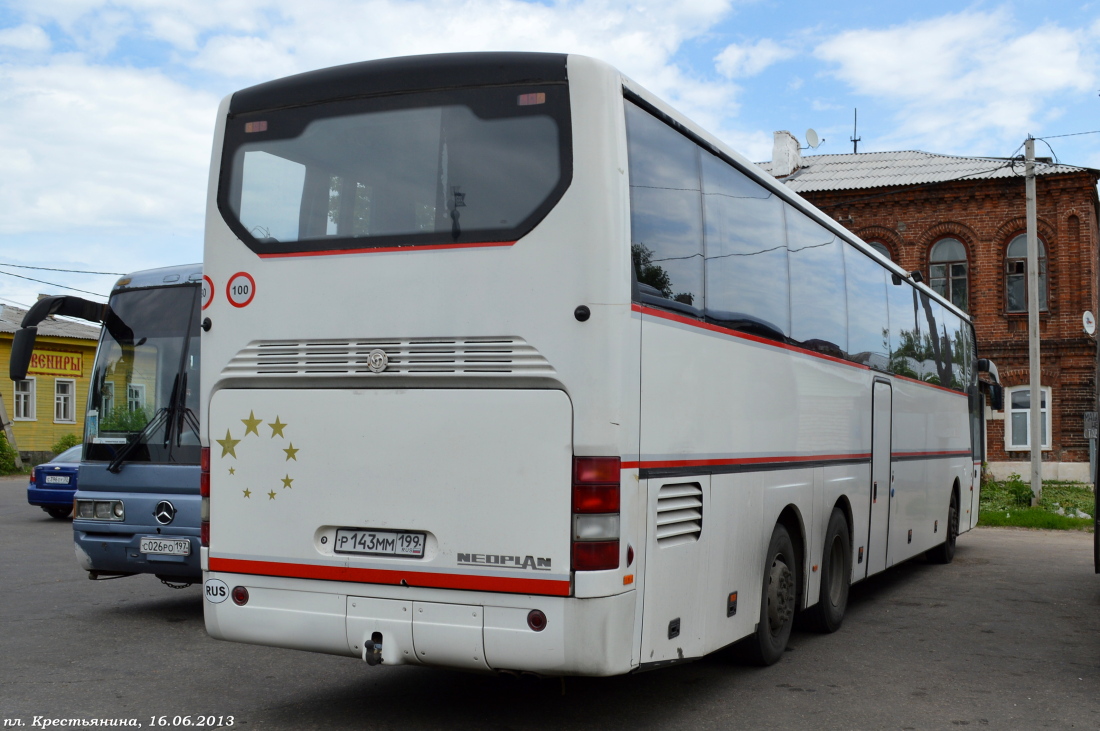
(703, 153, 791, 336)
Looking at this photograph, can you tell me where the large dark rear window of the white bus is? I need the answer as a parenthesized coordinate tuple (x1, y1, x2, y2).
(219, 84, 572, 254)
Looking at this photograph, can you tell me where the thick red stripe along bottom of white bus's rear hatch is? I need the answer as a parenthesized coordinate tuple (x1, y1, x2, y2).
(210, 556, 570, 597)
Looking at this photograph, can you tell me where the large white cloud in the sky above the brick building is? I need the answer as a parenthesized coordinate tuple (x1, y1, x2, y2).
(815, 11, 1100, 154)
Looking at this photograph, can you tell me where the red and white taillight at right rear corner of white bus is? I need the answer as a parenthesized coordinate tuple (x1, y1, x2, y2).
(572, 457, 622, 572)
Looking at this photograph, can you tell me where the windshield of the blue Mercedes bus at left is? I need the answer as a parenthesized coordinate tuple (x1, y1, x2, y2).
(85, 286, 199, 464)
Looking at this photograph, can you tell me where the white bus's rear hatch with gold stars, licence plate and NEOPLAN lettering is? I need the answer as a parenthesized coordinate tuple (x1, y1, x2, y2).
(209, 388, 572, 596)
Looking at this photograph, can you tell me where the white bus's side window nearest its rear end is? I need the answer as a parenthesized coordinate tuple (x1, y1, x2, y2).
(626, 102, 703, 313)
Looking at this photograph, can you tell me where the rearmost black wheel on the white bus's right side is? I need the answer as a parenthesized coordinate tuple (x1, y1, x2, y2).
(745, 525, 799, 665)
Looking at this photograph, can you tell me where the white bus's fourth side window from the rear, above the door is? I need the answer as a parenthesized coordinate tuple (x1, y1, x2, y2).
(844, 246, 890, 370)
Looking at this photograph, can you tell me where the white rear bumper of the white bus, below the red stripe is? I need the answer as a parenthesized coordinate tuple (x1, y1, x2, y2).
(204, 572, 637, 675)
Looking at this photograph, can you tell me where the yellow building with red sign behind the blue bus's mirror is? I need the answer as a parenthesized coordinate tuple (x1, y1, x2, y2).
(0, 304, 100, 464)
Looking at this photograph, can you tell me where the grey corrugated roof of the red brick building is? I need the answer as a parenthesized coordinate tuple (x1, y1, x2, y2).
(758, 149, 1098, 192)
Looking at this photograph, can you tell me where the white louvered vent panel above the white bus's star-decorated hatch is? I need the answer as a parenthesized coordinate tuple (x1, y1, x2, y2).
(222, 337, 554, 378)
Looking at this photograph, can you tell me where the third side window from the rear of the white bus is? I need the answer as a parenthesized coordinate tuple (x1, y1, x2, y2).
(784, 203, 848, 357)
